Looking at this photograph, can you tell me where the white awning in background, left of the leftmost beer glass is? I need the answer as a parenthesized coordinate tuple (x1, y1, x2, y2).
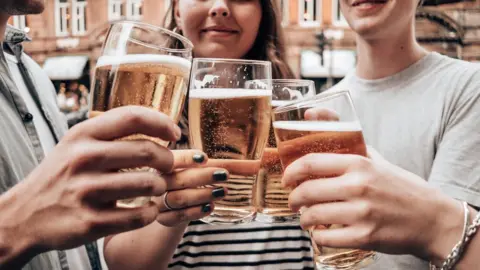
(43, 55, 88, 80)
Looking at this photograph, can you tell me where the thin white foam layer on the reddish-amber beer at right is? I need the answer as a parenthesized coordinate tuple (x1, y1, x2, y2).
(273, 121, 362, 132)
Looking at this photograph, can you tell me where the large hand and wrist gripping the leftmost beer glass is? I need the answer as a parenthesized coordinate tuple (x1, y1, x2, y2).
(0, 107, 195, 269)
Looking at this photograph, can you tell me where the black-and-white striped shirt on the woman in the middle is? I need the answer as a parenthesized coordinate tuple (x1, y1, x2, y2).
(169, 221, 313, 270)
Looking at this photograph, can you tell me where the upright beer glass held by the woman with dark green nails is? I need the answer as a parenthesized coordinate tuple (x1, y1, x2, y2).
(188, 59, 272, 224)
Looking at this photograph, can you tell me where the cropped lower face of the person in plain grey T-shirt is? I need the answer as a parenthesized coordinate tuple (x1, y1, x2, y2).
(340, 0, 419, 39)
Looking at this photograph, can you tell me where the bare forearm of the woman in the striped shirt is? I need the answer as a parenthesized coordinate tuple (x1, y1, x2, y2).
(105, 222, 187, 270)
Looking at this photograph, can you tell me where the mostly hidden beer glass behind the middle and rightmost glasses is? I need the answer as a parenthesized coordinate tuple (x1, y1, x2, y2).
(252, 79, 315, 223)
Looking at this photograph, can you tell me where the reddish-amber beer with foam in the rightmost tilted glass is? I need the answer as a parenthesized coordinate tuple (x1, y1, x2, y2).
(273, 121, 375, 269)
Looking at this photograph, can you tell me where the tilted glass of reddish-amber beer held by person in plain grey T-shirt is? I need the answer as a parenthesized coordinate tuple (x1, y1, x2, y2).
(273, 91, 375, 270)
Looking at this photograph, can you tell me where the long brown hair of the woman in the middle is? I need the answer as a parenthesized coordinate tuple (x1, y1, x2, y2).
(164, 0, 295, 79)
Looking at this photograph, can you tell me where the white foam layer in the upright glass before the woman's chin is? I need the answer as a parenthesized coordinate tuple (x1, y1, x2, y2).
(189, 88, 272, 99)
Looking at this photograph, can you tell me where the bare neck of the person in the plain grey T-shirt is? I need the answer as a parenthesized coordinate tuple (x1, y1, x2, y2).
(357, 24, 427, 80)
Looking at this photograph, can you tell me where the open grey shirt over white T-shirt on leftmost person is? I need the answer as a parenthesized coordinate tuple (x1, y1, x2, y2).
(0, 33, 95, 270)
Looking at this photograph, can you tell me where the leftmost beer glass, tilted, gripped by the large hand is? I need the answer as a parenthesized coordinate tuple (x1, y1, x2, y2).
(89, 21, 193, 208)
